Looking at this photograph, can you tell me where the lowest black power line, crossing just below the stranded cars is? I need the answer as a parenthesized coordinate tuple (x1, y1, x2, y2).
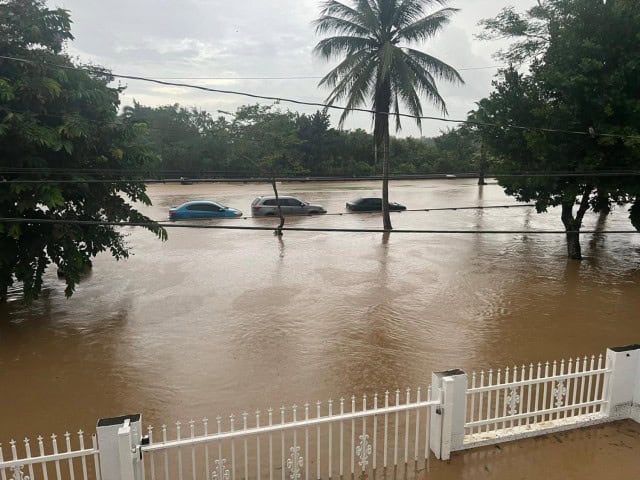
(0, 217, 640, 235)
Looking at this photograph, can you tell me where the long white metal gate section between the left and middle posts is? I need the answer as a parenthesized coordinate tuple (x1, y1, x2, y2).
(142, 388, 440, 480)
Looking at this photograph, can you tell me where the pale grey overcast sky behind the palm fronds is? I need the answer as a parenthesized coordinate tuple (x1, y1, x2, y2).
(48, 0, 534, 136)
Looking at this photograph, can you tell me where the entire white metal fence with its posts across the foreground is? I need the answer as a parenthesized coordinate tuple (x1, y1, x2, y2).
(0, 345, 640, 480)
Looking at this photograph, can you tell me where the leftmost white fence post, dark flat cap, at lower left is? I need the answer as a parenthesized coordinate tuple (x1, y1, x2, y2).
(96, 414, 142, 480)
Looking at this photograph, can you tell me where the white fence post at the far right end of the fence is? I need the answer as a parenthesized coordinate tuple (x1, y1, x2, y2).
(603, 345, 640, 422)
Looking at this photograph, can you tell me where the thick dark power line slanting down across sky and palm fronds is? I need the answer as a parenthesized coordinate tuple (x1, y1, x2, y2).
(0, 55, 640, 140)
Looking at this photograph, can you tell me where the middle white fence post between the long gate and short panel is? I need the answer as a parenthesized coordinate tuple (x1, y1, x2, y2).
(430, 369, 467, 460)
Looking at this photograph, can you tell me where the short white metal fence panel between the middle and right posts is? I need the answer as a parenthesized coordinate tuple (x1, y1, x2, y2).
(464, 355, 611, 448)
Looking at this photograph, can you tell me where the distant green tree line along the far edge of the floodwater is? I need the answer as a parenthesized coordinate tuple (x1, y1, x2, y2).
(122, 103, 479, 177)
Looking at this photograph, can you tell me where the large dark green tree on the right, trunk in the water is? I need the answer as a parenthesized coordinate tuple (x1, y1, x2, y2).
(474, 0, 640, 259)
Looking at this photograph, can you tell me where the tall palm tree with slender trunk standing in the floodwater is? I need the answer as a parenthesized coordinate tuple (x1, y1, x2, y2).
(314, 0, 464, 230)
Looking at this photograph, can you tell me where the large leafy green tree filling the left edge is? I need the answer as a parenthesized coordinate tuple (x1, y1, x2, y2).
(0, 0, 166, 301)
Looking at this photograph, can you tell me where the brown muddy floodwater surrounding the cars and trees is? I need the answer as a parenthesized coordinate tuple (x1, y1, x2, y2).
(0, 180, 640, 479)
